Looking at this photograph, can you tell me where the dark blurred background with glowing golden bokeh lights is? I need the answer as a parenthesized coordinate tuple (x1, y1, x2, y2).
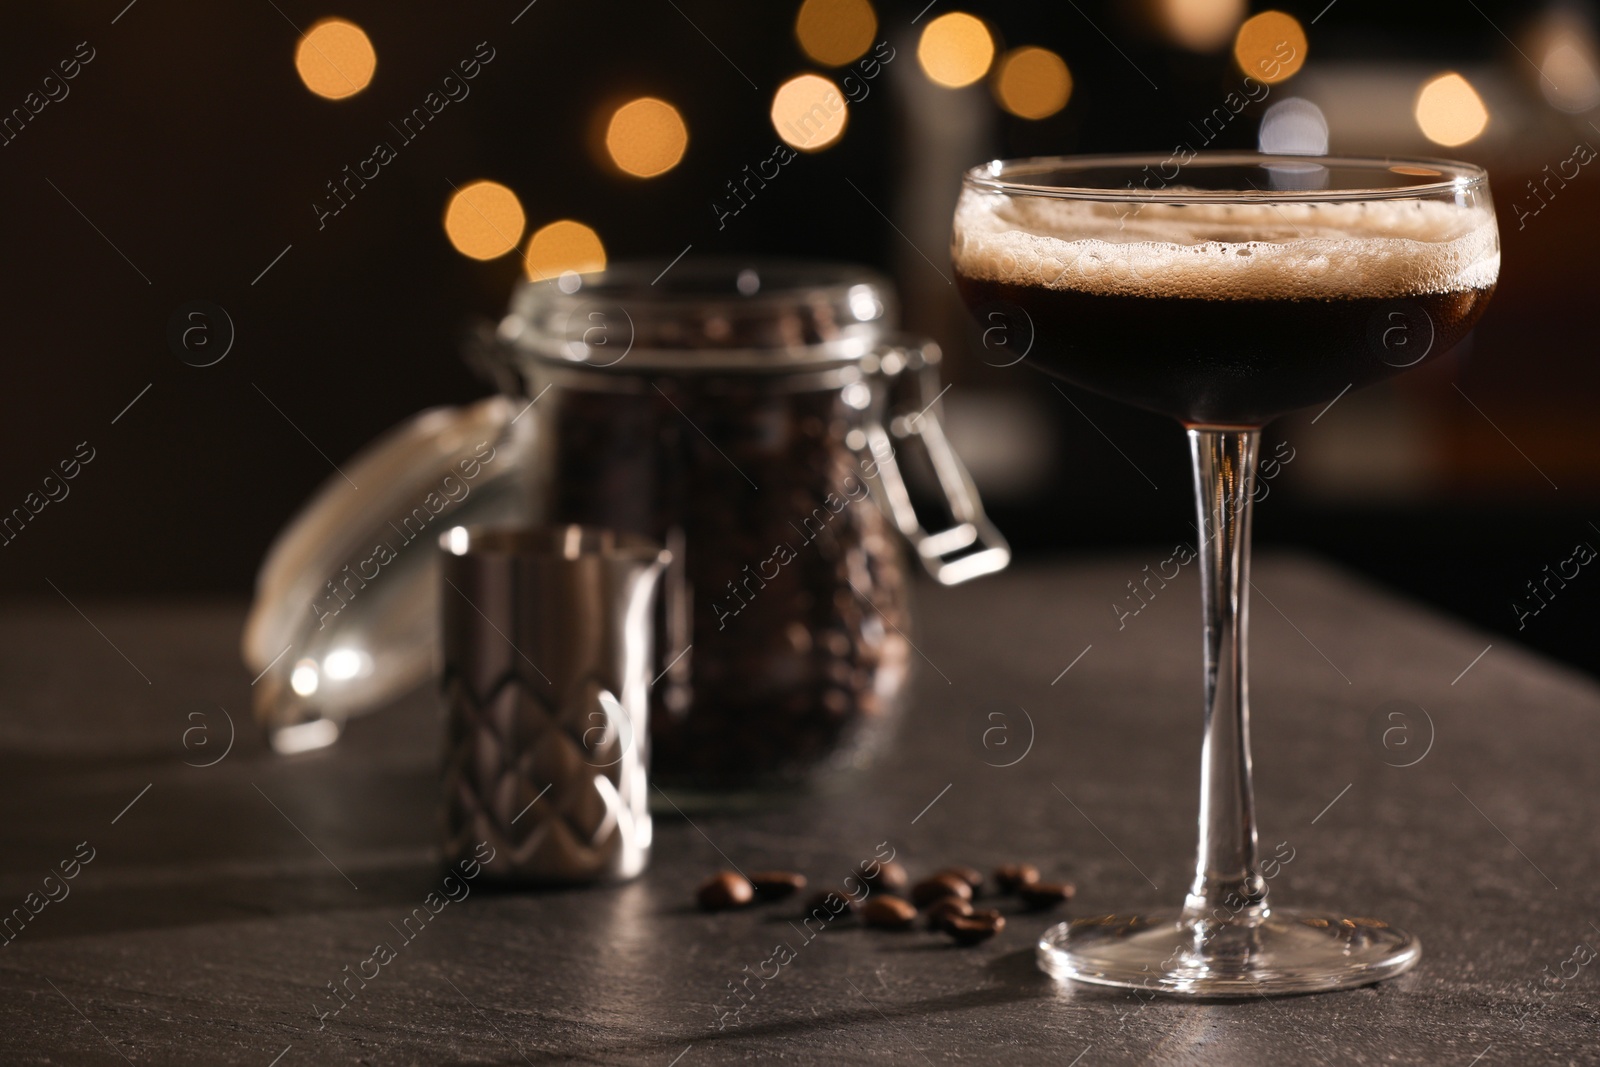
(0, 0, 1600, 672)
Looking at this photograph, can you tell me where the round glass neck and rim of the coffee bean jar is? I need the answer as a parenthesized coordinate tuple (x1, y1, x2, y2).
(498, 258, 898, 373)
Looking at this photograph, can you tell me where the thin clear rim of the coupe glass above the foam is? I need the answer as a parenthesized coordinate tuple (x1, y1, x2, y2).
(962, 152, 1488, 203)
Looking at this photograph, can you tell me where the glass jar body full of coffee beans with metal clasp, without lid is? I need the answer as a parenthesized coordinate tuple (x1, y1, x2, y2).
(494, 261, 1010, 790)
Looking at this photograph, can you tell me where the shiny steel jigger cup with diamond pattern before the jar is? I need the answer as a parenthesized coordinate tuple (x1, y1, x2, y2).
(438, 526, 670, 885)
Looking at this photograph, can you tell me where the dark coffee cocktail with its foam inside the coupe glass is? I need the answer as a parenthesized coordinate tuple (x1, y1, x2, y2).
(952, 190, 1499, 427)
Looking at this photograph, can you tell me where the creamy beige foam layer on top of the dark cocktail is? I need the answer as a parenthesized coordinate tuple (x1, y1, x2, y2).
(950, 189, 1499, 299)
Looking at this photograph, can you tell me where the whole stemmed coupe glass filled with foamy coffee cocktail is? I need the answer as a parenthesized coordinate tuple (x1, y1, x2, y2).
(952, 154, 1499, 997)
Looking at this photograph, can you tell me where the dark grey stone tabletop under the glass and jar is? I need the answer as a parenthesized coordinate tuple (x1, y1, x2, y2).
(0, 553, 1600, 1067)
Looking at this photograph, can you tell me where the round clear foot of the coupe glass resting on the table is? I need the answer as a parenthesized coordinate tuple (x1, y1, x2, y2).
(1038, 909, 1422, 997)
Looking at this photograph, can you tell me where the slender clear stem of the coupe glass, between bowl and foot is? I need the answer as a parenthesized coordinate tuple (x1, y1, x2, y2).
(1186, 429, 1267, 923)
